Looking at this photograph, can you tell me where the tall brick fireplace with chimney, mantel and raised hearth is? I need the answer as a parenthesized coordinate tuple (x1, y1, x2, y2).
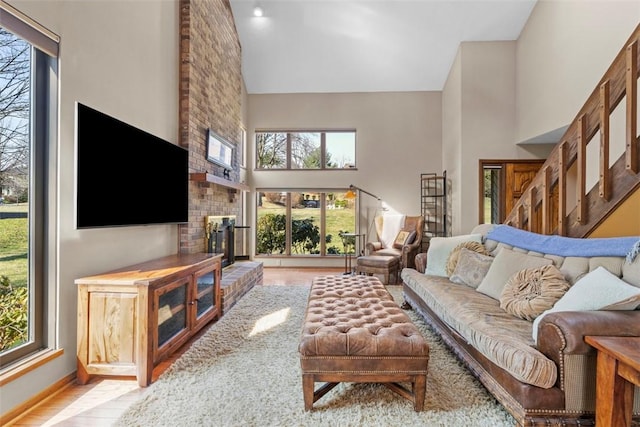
(179, 0, 262, 313)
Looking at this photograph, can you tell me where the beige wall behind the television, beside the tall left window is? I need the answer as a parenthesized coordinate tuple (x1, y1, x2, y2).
(0, 0, 179, 413)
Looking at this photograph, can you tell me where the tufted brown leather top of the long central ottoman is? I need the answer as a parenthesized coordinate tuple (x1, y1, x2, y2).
(299, 276, 429, 356)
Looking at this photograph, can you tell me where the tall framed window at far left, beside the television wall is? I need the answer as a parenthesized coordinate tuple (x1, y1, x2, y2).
(0, 8, 58, 369)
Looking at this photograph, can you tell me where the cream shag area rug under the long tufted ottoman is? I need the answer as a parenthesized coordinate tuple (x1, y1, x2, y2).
(116, 285, 515, 427)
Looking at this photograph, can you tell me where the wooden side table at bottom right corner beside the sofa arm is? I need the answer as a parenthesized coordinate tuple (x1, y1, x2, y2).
(584, 336, 640, 427)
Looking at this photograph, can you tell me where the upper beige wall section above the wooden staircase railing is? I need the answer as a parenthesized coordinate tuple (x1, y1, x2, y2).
(515, 0, 640, 141)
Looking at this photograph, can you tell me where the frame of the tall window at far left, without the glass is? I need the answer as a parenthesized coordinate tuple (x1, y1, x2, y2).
(0, 4, 60, 372)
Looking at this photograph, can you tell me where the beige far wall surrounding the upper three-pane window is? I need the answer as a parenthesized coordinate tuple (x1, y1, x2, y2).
(247, 92, 442, 265)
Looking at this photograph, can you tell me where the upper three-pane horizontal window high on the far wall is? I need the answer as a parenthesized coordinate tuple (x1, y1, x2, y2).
(255, 131, 356, 169)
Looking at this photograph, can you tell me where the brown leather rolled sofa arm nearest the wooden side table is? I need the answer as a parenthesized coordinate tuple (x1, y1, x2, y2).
(537, 310, 640, 363)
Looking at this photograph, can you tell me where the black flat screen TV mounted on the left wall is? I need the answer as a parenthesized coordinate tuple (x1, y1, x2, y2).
(76, 103, 189, 229)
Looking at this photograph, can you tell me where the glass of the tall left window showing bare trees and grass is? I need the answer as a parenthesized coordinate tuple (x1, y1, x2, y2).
(0, 28, 31, 352)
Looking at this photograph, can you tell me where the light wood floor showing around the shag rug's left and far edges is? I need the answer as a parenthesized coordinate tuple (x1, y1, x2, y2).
(8, 268, 344, 427)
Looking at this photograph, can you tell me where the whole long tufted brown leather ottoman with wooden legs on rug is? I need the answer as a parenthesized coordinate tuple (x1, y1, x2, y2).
(298, 276, 429, 411)
